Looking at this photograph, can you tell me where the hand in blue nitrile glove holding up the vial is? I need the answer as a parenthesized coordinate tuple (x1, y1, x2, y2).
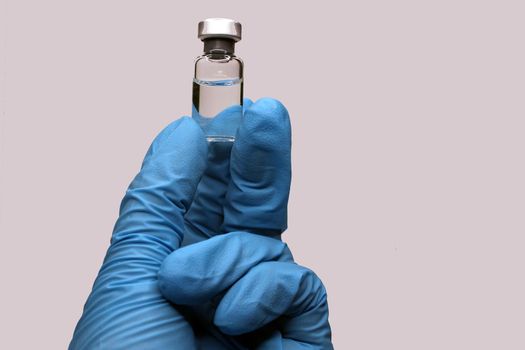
(69, 99, 332, 350)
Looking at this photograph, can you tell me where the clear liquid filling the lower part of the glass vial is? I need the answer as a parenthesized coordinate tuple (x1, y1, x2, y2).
(192, 79, 243, 142)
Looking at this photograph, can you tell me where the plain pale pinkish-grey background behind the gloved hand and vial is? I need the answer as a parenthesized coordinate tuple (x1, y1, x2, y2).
(0, 0, 525, 350)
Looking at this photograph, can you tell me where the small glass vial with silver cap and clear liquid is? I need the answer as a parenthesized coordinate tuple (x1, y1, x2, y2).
(192, 18, 243, 143)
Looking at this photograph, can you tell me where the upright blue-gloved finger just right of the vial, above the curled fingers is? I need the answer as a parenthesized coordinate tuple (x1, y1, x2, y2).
(222, 98, 292, 236)
